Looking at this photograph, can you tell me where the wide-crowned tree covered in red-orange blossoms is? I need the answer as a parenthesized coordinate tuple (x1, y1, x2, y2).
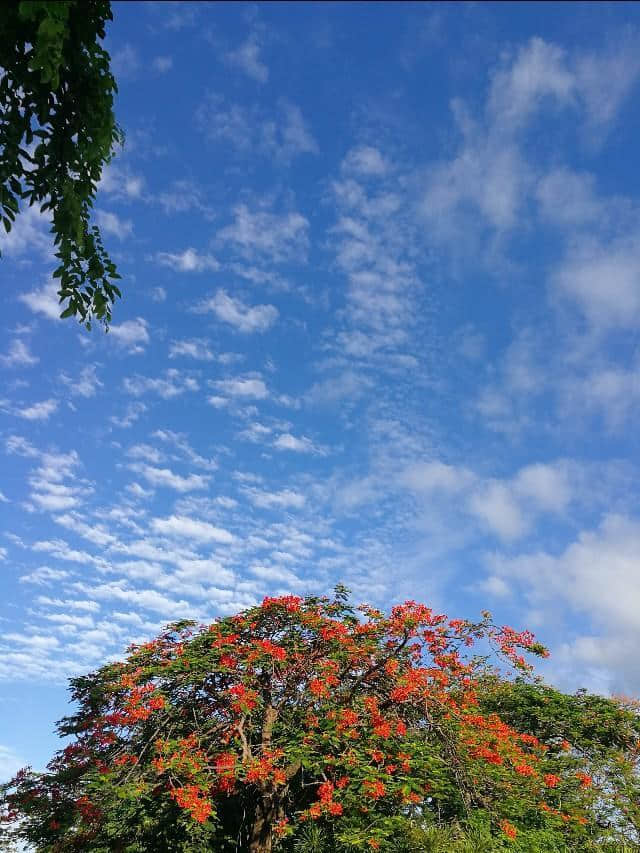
(4, 587, 632, 853)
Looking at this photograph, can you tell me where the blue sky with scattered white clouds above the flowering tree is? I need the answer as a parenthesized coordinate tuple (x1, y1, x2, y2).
(0, 3, 640, 775)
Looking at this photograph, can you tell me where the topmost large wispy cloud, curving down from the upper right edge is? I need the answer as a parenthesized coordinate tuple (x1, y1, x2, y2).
(423, 38, 640, 256)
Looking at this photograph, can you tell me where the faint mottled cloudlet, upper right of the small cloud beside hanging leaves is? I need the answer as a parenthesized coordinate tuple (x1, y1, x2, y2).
(217, 204, 309, 263)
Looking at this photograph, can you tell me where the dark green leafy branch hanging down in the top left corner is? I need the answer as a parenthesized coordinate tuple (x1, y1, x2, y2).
(0, 0, 124, 328)
